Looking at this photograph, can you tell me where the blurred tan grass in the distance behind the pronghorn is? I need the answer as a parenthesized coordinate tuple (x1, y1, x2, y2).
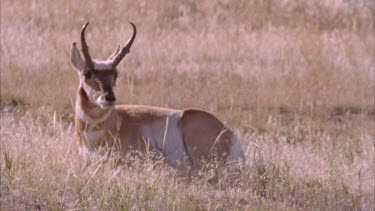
(1, 0, 375, 127)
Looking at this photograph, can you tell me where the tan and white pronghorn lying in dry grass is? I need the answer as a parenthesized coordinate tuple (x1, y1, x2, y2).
(70, 23, 243, 168)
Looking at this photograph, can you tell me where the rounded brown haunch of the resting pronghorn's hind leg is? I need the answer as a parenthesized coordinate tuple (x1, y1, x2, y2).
(179, 109, 233, 168)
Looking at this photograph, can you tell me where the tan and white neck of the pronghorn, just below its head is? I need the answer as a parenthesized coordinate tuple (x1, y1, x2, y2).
(76, 86, 113, 125)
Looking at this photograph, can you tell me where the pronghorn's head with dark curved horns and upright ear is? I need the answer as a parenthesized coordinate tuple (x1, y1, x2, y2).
(70, 22, 137, 109)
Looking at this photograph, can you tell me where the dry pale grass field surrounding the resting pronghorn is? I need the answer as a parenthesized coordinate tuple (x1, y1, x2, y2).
(0, 0, 375, 210)
